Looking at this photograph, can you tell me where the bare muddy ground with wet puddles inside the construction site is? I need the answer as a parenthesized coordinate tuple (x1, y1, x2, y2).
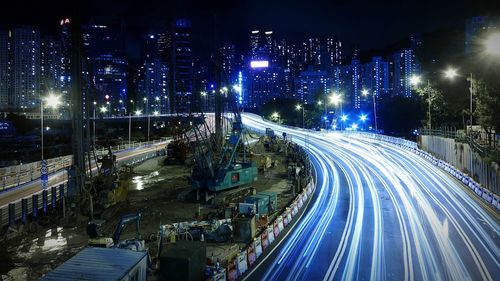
(0, 137, 292, 280)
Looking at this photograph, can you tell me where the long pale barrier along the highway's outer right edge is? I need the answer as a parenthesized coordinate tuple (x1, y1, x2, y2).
(345, 132, 500, 211)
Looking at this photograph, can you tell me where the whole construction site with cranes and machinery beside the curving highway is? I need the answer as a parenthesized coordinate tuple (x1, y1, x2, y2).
(0, 13, 313, 280)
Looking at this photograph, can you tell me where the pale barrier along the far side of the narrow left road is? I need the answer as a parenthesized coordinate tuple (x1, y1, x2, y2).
(0, 138, 167, 192)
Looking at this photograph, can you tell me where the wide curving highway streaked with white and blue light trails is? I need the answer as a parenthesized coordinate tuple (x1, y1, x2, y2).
(242, 114, 500, 281)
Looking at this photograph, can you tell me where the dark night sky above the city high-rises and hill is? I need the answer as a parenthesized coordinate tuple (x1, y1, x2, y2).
(0, 0, 500, 59)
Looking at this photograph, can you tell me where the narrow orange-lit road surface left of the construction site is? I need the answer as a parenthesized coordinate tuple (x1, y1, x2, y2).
(0, 142, 166, 208)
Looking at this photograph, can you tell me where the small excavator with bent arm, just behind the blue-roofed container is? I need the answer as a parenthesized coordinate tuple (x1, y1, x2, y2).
(87, 212, 146, 251)
